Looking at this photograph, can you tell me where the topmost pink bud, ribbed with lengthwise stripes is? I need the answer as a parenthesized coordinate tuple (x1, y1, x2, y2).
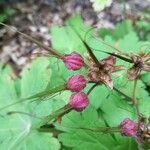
(63, 52, 84, 70)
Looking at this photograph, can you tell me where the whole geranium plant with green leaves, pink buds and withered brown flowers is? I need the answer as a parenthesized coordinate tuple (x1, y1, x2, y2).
(0, 16, 150, 150)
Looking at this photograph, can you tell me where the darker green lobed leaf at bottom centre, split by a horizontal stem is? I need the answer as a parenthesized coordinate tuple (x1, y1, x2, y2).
(56, 108, 114, 150)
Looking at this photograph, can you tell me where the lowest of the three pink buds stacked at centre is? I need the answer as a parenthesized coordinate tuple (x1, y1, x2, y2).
(69, 92, 89, 111)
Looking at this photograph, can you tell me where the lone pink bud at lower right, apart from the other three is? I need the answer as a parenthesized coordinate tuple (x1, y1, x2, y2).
(120, 118, 138, 137)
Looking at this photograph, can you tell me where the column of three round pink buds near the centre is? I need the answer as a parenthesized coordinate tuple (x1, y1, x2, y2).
(63, 52, 89, 111)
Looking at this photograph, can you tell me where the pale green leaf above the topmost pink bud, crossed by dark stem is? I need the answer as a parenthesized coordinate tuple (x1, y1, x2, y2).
(51, 16, 89, 54)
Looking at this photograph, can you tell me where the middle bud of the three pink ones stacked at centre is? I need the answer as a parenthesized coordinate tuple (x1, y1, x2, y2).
(67, 75, 86, 92)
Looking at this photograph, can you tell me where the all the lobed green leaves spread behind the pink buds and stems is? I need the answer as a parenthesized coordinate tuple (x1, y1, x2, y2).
(0, 16, 150, 150)
